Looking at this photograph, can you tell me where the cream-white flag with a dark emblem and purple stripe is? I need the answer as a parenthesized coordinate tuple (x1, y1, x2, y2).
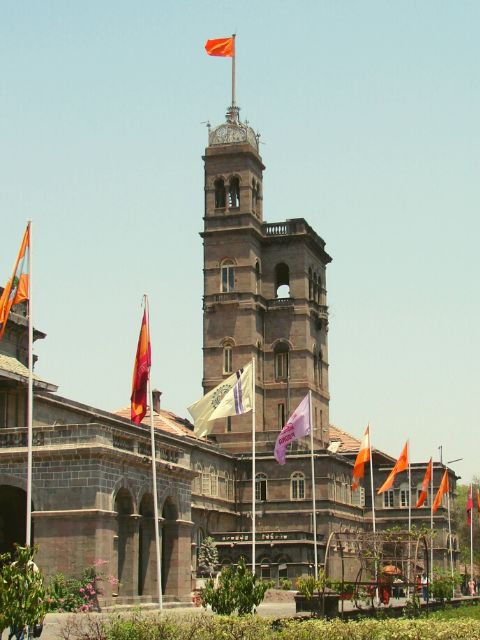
(188, 362, 254, 437)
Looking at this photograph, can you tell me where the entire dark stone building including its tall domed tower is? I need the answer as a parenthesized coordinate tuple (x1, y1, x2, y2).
(0, 101, 455, 602)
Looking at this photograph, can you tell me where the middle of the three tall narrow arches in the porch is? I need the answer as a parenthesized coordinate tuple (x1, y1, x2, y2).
(138, 493, 156, 596)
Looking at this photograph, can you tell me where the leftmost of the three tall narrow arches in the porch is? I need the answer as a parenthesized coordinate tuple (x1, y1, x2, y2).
(115, 488, 134, 596)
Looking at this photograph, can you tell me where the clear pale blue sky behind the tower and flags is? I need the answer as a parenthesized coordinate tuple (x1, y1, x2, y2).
(0, 0, 480, 482)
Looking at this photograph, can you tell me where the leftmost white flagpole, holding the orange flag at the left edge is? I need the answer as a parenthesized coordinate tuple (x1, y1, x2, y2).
(26, 220, 33, 546)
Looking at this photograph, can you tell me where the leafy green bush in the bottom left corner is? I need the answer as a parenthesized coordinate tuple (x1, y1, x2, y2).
(0, 546, 46, 630)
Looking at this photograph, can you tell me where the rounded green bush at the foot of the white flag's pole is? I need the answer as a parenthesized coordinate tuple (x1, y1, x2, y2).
(202, 558, 273, 616)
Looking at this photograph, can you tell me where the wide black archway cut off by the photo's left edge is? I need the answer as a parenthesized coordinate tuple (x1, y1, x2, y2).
(0, 485, 29, 554)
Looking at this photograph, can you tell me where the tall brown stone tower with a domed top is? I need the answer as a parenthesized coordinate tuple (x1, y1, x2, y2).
(201, 107, 331, 452)
